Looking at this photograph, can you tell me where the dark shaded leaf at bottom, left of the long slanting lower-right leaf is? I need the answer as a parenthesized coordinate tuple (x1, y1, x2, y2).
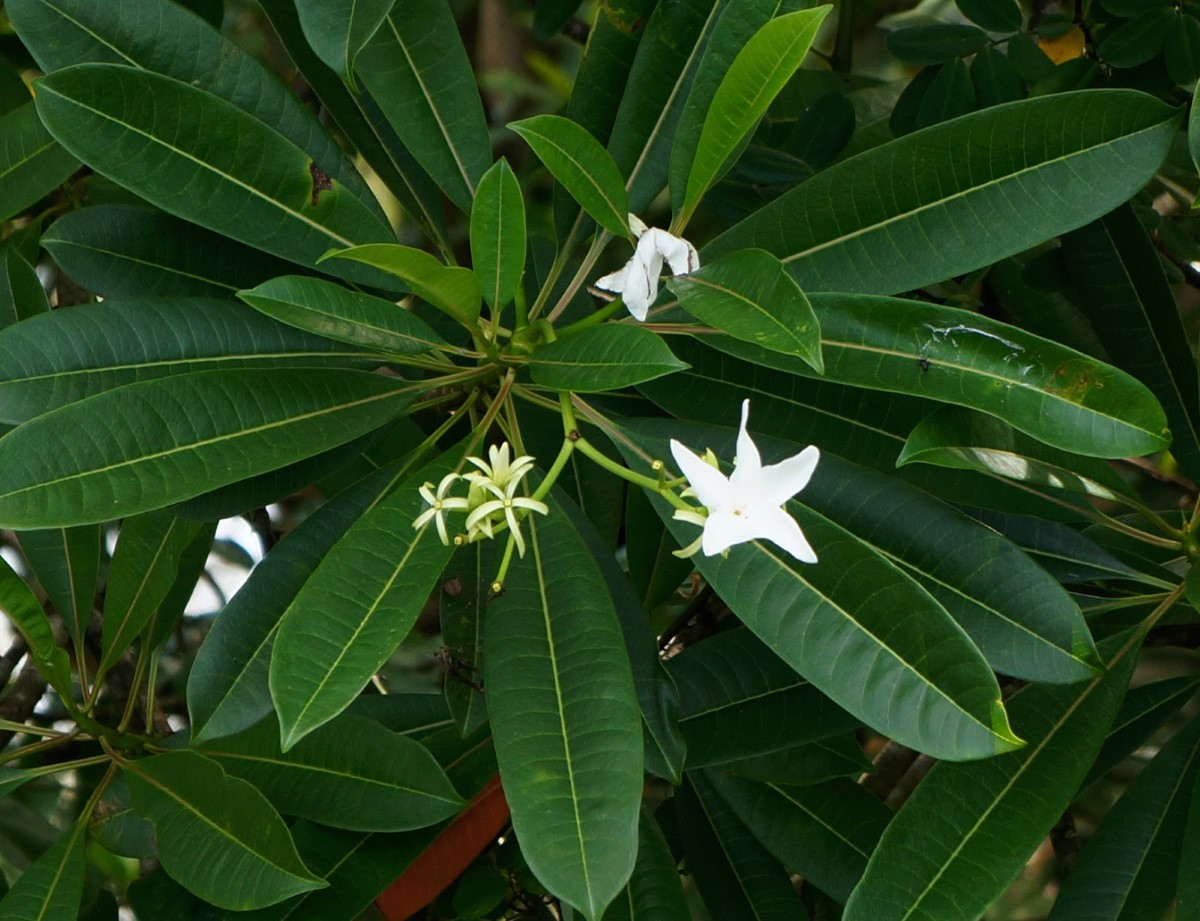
(706, 771, 892, 902)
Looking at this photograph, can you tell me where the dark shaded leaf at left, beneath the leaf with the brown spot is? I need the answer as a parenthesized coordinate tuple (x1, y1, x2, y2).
(42, 205, 302, 297)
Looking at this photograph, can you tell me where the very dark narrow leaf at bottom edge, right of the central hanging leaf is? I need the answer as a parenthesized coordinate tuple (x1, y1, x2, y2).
(674, 771, 808, 921)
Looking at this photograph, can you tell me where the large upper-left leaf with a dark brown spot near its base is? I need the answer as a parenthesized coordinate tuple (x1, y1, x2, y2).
(37, 64, 391, 283)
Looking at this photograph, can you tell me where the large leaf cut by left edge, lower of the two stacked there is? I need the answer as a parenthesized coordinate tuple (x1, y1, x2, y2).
(0, 368, 412, 529)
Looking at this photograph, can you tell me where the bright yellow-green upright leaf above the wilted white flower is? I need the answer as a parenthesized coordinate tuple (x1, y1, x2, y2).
(682, 5, 833, 219)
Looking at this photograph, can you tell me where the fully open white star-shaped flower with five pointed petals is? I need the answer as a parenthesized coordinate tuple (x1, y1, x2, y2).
(671, 399, 821, 562)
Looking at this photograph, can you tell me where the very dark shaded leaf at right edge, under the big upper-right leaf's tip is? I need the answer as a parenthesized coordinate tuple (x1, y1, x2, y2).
(1062, 205, 1200, 476)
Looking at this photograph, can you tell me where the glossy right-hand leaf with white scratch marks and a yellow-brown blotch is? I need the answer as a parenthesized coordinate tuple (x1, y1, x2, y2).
(719, 294, 1170, 457)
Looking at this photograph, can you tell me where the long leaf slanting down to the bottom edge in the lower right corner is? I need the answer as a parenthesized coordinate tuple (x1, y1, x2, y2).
(845, 633, 1141, 921)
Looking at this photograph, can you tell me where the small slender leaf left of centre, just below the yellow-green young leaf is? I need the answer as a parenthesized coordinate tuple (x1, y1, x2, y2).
(238, 275, 446, 355)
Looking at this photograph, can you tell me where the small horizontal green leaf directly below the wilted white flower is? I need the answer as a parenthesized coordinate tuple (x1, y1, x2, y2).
(529, 323, 688, 393)
